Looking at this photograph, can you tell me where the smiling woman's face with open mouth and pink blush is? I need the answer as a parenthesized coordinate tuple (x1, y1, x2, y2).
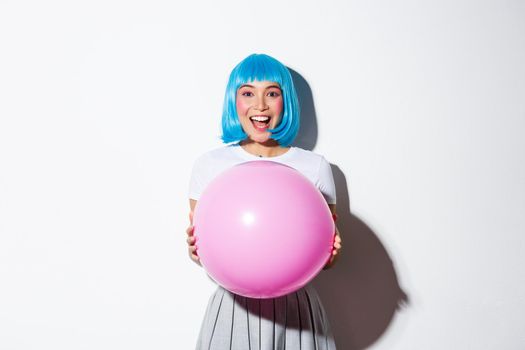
(235, 81, 283, 143)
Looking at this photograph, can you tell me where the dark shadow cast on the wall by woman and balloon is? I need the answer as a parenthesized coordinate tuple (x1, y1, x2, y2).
(290, 69, 408, 350)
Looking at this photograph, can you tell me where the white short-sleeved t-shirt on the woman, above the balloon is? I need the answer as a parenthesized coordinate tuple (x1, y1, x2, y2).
(189, 144, 336, 204)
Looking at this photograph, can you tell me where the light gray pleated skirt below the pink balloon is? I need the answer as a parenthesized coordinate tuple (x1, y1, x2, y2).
(196, 285, 335, 350)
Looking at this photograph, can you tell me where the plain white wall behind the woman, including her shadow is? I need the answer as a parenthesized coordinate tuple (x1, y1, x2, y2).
(0, 0, 525, 350)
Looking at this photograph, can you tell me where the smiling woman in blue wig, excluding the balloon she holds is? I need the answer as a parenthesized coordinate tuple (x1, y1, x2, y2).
(186, 54, 341, 350)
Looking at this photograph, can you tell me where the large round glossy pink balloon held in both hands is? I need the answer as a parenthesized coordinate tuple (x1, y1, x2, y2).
(193, 161, 335, 298)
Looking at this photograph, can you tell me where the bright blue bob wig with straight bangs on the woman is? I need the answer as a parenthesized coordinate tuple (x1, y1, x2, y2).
(221, 54, 301, 146)
